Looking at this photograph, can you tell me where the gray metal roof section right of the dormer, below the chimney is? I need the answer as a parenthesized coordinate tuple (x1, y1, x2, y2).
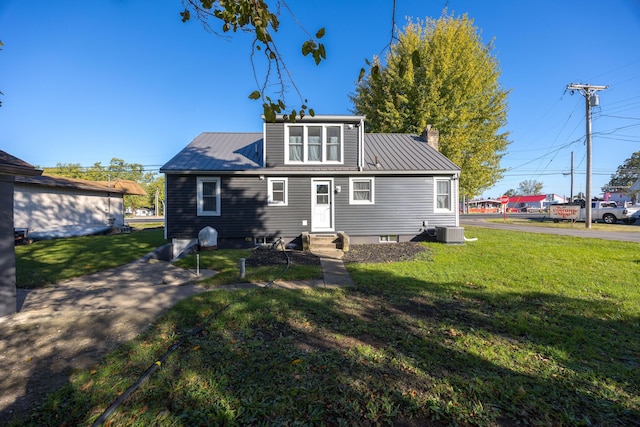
(363, 133, 460, 172)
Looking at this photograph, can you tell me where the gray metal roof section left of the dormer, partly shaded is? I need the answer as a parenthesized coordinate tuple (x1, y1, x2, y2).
(160, 132, 263, 172)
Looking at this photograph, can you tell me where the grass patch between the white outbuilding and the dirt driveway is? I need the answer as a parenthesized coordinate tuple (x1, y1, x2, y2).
(16, 229, 166, 289)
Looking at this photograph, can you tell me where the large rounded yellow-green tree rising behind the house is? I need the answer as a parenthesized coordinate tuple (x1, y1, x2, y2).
(351, 14, 509, 198)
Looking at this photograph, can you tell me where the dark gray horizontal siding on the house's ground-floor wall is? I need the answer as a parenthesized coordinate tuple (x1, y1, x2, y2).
(166, 174, 457, 241)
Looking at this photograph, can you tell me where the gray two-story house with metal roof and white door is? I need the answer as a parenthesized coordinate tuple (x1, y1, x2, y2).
(160, 116, 460, 252)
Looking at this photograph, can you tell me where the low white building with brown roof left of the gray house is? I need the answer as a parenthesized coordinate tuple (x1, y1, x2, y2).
(13, 176, 146, 231)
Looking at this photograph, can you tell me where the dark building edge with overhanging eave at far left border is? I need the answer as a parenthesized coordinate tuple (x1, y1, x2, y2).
(0, 150, 42, 316)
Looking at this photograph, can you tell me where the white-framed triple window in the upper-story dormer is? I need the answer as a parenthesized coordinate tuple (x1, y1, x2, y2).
(285, 124, 343, 164)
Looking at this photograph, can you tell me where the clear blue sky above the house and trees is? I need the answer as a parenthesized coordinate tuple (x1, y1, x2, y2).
(0, 0, 640, 197)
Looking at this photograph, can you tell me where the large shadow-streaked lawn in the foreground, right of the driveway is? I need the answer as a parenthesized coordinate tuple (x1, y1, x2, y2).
(10, 227, 640, 426)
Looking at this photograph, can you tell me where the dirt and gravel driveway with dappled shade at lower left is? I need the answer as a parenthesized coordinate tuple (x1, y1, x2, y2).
(0, 260, 213, 425)
